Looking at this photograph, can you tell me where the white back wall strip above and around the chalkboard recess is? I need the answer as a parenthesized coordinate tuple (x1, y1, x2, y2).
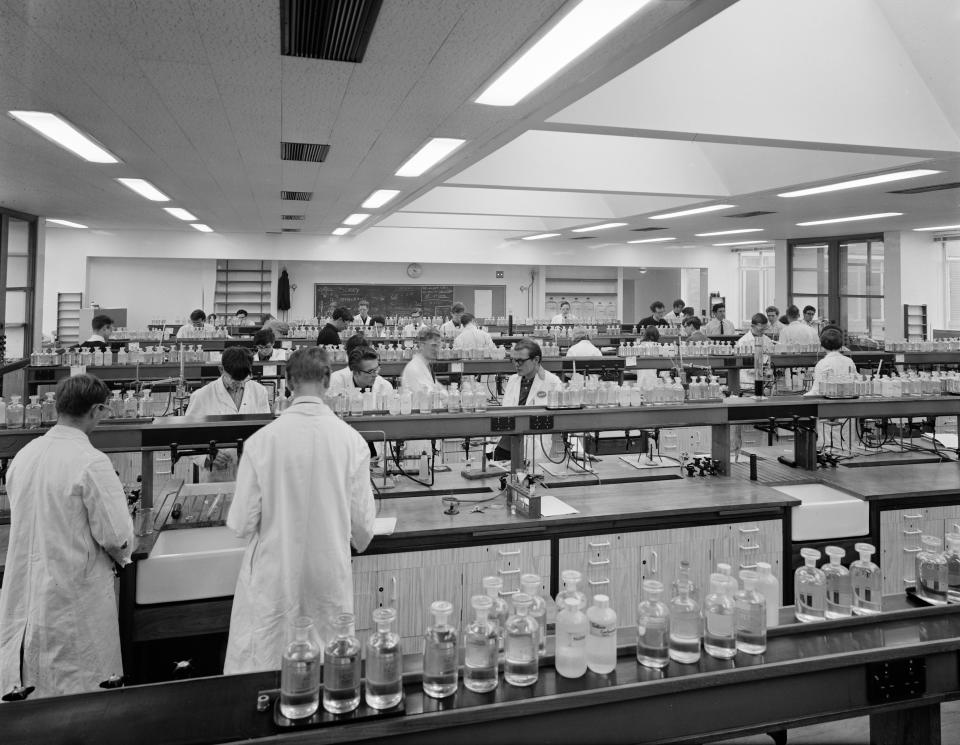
(42, 228, 739, 330)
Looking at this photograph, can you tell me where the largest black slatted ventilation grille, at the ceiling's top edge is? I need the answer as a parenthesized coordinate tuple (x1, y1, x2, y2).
(280, 0, 382, 62)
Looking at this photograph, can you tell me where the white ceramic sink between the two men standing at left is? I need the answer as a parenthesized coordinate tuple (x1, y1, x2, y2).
(137, 526, 248, 605)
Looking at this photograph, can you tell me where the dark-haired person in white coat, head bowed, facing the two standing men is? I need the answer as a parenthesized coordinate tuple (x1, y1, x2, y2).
(186, 347, 270, 482)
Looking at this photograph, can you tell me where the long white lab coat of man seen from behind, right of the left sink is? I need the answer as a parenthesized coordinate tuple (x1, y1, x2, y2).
(223, 396, 375, 675)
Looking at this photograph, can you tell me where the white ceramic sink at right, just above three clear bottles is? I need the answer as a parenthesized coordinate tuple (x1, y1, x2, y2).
(772, 484, 870, 541)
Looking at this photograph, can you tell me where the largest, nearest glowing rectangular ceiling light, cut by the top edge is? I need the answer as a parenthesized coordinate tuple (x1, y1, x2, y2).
(476, 0, 649, 106)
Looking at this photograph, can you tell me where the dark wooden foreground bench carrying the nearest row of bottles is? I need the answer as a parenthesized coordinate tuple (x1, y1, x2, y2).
(0, 595, 960, 745)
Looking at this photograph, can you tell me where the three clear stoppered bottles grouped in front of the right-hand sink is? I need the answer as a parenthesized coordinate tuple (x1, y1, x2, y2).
(794, 539, 880, 622)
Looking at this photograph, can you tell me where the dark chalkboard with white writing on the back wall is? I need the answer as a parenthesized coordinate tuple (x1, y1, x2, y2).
(314, 284, 454, 318)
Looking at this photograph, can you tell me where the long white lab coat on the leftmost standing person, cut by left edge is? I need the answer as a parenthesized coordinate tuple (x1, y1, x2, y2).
(0, 425, 134, 696)
